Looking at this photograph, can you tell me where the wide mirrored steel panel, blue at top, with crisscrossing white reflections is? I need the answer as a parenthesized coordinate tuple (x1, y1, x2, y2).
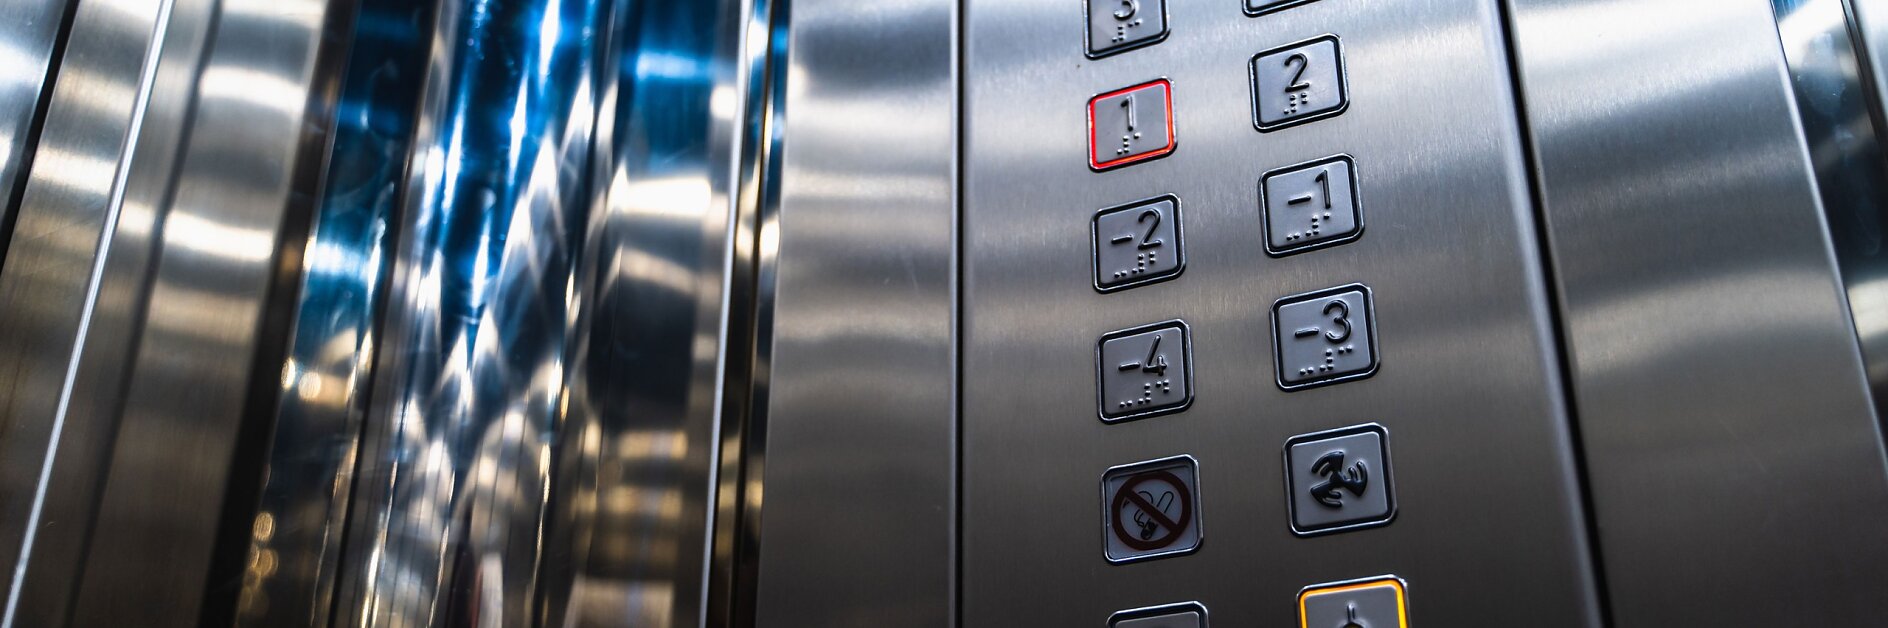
(336, 0, 604, 626)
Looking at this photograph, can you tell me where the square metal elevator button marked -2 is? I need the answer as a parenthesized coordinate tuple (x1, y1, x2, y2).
(1089, 194, 1186, 292)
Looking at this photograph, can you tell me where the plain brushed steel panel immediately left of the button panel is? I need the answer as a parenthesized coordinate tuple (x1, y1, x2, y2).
(750, 0, 959, 626)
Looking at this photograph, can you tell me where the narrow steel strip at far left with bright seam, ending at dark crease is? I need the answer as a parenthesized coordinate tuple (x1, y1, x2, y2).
(0, 2, 204, 626)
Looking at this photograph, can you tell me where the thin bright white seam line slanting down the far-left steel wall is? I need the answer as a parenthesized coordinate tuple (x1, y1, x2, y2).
(0, 0, 176, 626)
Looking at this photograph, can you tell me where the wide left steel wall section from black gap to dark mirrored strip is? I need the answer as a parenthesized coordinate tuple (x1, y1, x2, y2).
(0, 0, 347, 626)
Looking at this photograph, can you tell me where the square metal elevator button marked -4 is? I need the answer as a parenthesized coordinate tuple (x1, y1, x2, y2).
(1095, 321, 1193, 422)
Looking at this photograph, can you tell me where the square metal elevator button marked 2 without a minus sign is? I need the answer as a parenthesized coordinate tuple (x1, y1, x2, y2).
(1252, 36, 1350, 130)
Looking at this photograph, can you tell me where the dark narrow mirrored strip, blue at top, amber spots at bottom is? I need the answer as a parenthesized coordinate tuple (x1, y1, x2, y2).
(236, 0, 432, 626)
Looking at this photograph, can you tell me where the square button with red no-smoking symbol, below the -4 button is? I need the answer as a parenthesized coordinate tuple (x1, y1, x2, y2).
(1101, 450, 1201, 564)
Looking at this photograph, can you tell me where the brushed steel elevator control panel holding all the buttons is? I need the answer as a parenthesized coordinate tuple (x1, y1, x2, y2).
(961, 0, 1597, 618)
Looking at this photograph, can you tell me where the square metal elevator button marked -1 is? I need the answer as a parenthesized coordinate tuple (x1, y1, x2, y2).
(1259, 155, 1363, 255)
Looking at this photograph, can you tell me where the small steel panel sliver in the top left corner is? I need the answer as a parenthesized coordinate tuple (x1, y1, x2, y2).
(0, 0, 72, 239)
